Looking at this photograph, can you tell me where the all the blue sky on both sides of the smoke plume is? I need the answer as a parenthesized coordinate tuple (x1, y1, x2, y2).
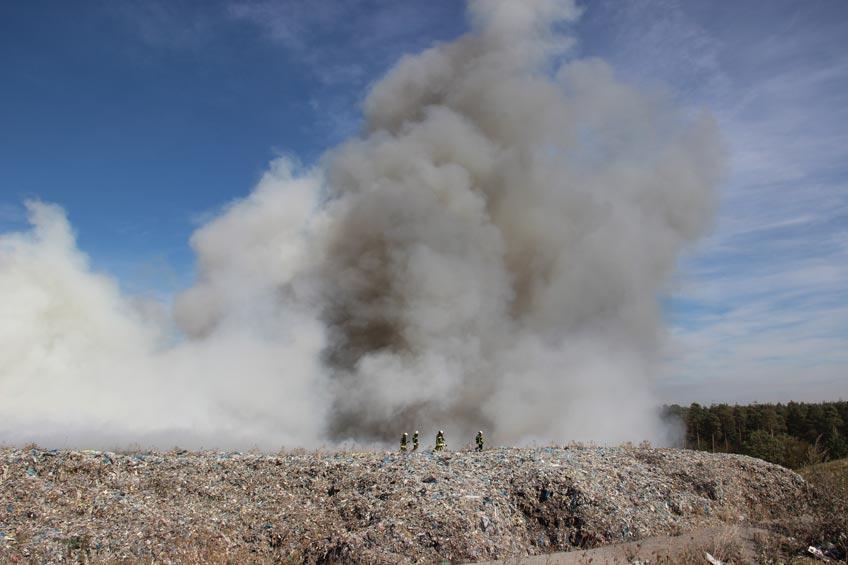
(0, 0, 848, 402)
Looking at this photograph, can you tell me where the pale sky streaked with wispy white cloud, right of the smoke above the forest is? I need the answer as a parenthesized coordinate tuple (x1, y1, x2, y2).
(589, 0, 848, 402)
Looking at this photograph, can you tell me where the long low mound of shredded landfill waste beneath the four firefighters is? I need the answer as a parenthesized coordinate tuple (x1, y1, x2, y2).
(0, 446, 813, 563)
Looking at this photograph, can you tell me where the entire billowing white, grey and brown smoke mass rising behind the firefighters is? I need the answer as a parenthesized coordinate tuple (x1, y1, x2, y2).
(0, 0, 722, 447)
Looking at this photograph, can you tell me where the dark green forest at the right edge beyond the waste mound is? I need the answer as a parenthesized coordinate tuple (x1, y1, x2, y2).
(663, 400, 848, 469)
